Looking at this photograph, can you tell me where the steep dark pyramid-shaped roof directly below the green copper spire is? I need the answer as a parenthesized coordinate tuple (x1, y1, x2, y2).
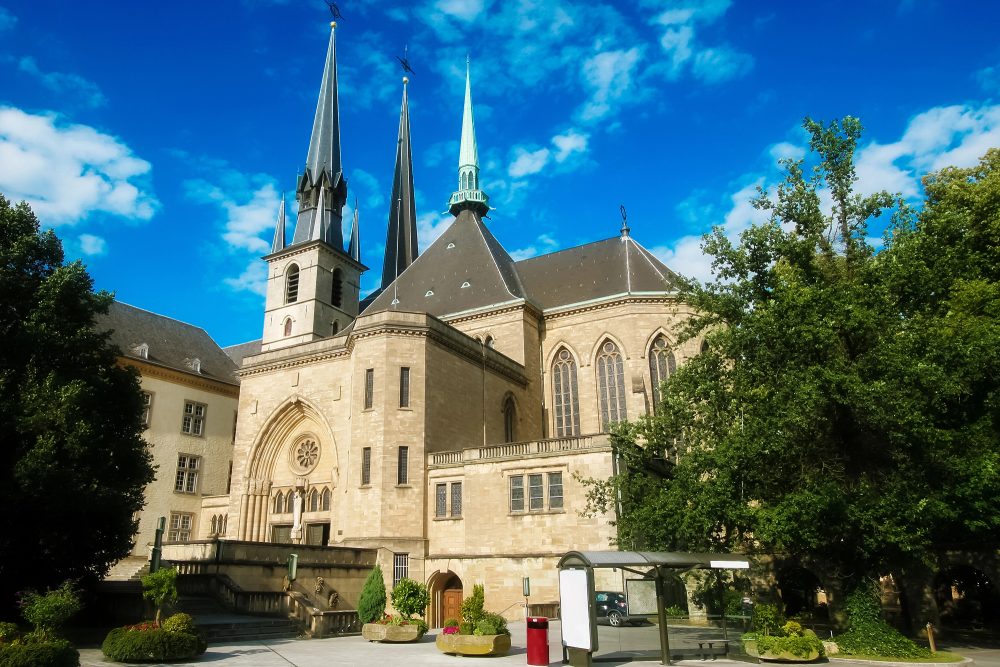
(365, 209, 525, 316)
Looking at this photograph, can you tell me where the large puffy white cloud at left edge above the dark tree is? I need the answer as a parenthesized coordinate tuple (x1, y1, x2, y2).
(0, 107, 160, 225)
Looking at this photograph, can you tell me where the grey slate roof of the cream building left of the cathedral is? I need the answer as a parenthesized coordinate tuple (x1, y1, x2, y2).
(96, 301, 239, 385)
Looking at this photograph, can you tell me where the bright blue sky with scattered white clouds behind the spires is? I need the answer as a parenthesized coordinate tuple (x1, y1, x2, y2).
(0, 0, 1000, 345)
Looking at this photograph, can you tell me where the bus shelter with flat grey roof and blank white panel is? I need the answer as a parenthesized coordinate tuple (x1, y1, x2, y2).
(559, 551, 750, 666)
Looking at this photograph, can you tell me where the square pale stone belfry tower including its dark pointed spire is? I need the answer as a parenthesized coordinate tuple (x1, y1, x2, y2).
(261, 23, 366, 352)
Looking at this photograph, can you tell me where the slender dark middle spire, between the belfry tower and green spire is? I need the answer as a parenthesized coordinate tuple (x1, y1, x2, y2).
(382, 76, 420, 289)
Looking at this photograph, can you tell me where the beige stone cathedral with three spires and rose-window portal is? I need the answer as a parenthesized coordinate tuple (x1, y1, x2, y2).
(115, 25, 701, 626)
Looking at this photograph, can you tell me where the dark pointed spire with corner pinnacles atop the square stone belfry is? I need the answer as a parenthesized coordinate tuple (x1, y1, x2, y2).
(292, 22, 347, 252)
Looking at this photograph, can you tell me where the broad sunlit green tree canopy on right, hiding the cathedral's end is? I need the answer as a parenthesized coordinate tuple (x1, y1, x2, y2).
(590, 117, 1000, 600)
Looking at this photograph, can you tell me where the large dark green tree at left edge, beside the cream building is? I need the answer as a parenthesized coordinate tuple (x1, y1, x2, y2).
(0, 195, 153, 613)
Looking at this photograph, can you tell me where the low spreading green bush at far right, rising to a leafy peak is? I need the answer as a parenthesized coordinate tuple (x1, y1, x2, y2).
(835, 581, 931, 658)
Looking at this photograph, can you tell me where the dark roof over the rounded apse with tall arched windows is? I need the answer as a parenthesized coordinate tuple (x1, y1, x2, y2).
(514, 236, 677, 309)
